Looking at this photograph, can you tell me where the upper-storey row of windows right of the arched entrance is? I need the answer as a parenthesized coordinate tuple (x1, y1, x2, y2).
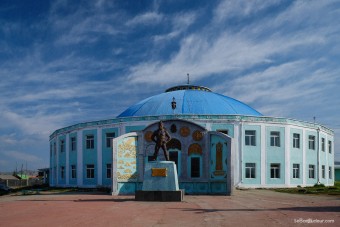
(244, 130, 332, 153)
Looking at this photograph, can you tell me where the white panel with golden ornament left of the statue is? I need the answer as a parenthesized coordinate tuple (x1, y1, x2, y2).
(117, 137, 137, 182)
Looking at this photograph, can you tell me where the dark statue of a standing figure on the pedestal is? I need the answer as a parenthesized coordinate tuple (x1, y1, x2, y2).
(151, 121, 171, 161)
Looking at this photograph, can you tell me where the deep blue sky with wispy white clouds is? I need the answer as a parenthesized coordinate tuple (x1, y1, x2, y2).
(0, 0, 340, 171)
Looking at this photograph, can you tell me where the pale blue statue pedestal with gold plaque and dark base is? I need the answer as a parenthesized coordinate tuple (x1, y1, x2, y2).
(135, 161, 184, 201)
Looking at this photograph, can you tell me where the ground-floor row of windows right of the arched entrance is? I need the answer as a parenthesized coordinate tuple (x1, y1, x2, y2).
(245, 163, 333, 179)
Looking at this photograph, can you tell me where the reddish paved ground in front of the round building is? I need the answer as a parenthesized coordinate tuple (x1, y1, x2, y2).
(0, 190, 340, 227)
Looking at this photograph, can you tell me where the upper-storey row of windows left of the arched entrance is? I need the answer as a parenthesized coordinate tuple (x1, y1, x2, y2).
(50, 132, 116, 156)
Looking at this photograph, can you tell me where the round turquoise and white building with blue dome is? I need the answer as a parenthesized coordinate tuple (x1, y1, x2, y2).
(50, 85, 334, 194)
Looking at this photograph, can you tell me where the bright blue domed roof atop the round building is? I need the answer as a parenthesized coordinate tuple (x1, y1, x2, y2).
(118, 85, 262, 118)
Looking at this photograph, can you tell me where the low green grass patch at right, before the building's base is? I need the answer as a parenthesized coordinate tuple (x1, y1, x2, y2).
(274, 181, 340, 195)
